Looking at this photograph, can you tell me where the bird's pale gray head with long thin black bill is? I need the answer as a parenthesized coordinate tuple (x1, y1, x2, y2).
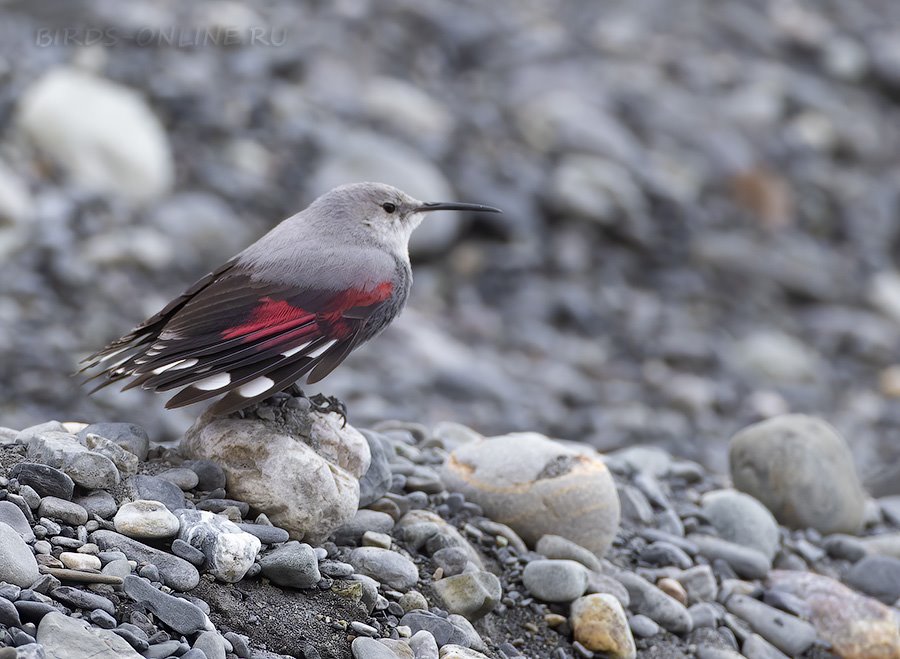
(304, 183, 500, 253)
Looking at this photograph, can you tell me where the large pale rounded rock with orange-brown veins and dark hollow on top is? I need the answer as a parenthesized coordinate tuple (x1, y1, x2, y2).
(441, 433, 619, 556)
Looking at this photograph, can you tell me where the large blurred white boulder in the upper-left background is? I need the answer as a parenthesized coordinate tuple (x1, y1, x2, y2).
(17, 68, 174, 203)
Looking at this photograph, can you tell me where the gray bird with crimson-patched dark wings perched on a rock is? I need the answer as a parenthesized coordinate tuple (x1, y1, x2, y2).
(79, 182, 502, 422)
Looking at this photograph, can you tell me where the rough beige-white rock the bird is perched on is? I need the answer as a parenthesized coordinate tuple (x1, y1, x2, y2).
(181, 406, 371, 542)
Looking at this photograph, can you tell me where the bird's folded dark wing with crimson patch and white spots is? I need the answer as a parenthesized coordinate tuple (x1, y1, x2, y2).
(85, 263, 394, 414)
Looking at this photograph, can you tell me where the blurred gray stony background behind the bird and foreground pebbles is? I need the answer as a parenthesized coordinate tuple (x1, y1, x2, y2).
(0, 0, 900, 495)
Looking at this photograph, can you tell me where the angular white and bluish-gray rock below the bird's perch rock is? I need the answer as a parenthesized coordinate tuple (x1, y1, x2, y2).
(177, 510, 260, 583)
